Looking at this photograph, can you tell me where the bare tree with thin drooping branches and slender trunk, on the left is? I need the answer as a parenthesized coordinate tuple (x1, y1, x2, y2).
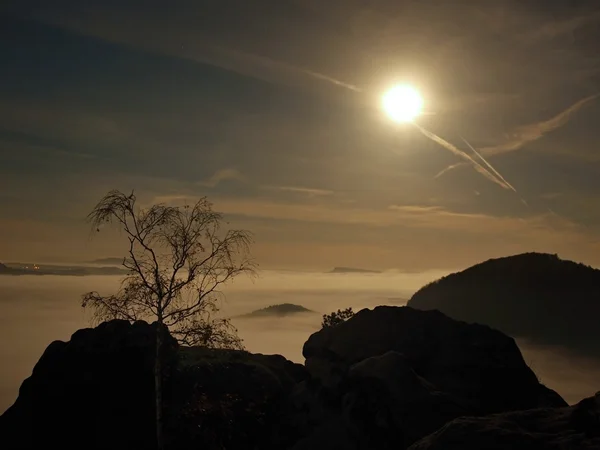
(82, 190, 256, 450)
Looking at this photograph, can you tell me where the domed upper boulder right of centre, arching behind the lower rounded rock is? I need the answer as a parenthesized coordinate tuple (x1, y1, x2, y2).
(303, 306, 566, 414)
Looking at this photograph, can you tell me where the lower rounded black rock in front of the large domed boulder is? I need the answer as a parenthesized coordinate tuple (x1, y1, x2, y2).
(294, 352, 473, 450)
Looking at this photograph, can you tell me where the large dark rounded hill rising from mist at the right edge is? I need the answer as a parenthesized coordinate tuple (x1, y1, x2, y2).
(408, 253, 600, 355)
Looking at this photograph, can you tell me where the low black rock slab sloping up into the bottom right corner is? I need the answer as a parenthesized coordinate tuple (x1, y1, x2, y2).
(409, 393, 600, 450)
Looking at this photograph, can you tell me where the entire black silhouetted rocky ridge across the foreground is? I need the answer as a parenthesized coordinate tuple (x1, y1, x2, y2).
(0, 306, 584, 450)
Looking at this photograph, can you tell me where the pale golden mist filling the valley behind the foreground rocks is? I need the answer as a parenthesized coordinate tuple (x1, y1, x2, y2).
(0, 270, 600, 412)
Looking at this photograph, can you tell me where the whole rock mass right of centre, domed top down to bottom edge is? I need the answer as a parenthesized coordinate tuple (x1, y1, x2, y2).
(294, 306, 567, 450)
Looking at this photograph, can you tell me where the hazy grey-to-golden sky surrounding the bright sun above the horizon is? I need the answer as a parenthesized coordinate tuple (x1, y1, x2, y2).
(0, 0, 600, 272)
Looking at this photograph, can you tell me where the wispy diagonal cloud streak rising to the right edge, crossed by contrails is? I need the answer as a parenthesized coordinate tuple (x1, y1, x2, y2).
(436, 94, 600, 178)
